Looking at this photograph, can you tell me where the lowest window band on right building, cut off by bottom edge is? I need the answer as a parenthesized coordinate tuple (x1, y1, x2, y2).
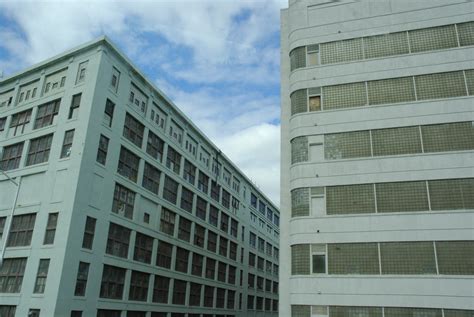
(291, 305, 474, 317)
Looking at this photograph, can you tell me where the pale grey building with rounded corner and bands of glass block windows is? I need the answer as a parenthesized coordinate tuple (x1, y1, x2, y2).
(280, 0, 474, 317)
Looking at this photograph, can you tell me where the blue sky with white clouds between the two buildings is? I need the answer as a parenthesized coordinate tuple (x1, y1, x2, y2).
(0, 0, 287, 205)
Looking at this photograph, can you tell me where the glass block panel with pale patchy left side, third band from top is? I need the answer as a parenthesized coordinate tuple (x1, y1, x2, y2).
(324, 131, 371, 160)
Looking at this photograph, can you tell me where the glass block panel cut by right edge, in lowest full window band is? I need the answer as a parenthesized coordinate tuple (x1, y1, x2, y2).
(436, 241, 474, 275)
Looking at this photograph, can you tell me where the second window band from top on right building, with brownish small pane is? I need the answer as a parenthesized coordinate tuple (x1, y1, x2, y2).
(290, 69, 474, 115)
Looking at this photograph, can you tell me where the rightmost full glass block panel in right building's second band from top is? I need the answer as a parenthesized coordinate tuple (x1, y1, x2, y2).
(415, 71, 467, 100)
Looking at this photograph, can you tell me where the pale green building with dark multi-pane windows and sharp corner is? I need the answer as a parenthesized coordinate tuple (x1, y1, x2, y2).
(0, 38, 280, 317)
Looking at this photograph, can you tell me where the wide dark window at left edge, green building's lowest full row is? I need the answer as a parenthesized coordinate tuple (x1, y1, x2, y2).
(0, 258, 26, 293)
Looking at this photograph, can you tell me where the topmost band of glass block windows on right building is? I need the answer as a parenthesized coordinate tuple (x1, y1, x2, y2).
(290, 22, 474, 71)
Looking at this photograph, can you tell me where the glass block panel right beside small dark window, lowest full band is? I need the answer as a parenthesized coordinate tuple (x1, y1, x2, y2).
(328, 243, 380, 274)
